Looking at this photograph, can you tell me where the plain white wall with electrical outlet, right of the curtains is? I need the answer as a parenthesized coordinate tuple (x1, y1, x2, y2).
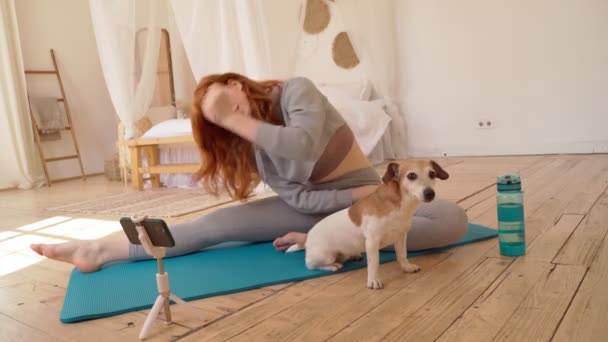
(398, 0, 608, 155)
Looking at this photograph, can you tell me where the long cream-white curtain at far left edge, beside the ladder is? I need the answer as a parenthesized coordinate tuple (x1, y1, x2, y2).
(0, 0, 44, 189)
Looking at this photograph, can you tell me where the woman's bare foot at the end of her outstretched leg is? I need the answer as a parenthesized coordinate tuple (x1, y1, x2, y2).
(30, 241, 102, 272)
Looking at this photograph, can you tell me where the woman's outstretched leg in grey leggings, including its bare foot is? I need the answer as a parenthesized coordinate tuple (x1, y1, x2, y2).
(31, 197, 324, 272)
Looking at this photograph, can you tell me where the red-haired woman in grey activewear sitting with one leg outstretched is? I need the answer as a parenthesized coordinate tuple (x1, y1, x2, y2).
(32, 73, 467, 272)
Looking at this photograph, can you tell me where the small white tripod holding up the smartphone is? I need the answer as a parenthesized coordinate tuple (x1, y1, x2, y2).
(131, 216, 186, 340)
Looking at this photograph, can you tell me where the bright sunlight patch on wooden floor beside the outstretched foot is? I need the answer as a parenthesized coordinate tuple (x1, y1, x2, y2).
(0, 216, 122, 276)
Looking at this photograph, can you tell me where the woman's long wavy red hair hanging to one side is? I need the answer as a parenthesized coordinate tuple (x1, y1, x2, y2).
(190, 73, 281, 200)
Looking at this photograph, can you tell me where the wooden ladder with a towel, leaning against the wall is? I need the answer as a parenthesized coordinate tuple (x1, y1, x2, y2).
(25, 49, 86, 186)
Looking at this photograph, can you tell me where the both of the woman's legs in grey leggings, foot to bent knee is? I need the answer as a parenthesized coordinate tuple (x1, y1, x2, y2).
(32, 197, 467, 272)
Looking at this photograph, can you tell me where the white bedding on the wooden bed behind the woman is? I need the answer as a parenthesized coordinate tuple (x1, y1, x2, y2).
(142, 85, 405, 188)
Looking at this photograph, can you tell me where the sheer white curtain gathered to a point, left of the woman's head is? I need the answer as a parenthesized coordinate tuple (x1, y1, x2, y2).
(90, 0, 161, 139)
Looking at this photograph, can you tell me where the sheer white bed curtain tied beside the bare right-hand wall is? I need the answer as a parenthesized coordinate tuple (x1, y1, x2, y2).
(335, 0, 407, 158)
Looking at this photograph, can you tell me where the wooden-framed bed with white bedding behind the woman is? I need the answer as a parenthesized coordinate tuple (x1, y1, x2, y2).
(128, 81, 406, 190)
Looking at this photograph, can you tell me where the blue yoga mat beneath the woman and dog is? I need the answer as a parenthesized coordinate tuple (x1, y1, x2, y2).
(60, 224, 497, 323)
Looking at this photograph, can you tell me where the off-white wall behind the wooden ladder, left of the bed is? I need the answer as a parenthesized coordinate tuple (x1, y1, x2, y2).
(16, 0, 194, 179)
